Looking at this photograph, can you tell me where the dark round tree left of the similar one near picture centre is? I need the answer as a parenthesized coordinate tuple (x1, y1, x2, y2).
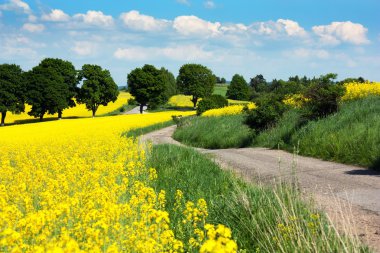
(128, 64, 167, 113)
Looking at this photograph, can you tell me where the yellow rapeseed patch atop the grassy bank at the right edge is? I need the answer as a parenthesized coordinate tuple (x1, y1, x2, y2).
(342, 82, 380, 100)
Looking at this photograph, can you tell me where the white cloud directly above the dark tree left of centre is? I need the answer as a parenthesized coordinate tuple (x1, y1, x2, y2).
(120, 11, 170, 31)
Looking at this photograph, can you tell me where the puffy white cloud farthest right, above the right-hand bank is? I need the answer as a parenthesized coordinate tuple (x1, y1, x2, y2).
(312, 21, 369, 45)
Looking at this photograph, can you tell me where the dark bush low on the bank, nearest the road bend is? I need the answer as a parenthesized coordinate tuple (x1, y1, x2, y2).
(245, 94, 286, 132)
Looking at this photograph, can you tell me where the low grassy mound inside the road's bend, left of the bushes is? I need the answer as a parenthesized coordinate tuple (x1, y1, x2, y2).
(173, 115, 252, 149)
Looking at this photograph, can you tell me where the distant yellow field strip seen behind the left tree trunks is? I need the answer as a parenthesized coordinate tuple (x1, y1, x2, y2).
(5, 92, 132, 123)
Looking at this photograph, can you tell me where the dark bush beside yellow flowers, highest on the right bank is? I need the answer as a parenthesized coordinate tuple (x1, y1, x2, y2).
(303, 74, 345, 119)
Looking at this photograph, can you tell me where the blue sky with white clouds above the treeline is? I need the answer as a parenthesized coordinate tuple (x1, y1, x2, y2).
(0, 0, 380, 86)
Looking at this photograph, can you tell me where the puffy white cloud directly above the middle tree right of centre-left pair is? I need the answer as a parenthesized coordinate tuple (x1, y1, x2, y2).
(173, 16, 221, 37)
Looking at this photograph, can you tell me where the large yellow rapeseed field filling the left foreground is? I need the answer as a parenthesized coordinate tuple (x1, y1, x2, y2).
(0, 112, 237, 252)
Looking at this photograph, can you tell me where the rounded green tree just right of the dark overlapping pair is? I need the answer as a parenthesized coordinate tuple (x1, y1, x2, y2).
(77, 64, 119, 117)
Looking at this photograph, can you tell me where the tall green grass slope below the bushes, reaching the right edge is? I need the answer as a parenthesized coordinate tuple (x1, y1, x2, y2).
(253, 97, 380, 170)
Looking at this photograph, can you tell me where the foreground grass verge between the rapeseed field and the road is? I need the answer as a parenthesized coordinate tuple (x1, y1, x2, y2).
(149, 145, 368, 252)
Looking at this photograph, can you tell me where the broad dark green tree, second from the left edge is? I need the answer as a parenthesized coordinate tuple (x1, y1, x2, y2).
(26, 59, 71, 121)
